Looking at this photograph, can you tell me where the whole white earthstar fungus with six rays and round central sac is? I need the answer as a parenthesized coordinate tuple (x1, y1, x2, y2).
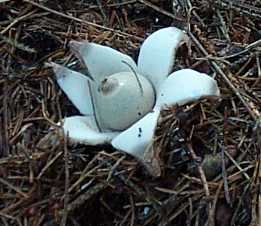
(52, 27, 220, 176)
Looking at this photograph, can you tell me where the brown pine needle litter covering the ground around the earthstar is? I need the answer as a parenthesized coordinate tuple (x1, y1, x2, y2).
(0, 0, 261, 226)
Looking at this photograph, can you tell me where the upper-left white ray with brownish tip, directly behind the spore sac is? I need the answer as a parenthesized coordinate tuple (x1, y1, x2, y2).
(69, 41, 137, 82)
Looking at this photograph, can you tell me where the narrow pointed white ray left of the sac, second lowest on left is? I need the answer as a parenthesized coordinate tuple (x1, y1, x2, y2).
(51, 63, 93, 115)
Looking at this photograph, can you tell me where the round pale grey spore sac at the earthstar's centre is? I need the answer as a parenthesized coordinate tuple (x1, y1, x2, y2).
(95, 72, 155, 130)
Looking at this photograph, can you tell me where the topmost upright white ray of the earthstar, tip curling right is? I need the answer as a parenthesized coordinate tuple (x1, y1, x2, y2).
(138, 27, 186, 89)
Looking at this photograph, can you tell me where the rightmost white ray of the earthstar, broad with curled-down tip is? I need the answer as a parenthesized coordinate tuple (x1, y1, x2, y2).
(156, 69, 220, 107)
